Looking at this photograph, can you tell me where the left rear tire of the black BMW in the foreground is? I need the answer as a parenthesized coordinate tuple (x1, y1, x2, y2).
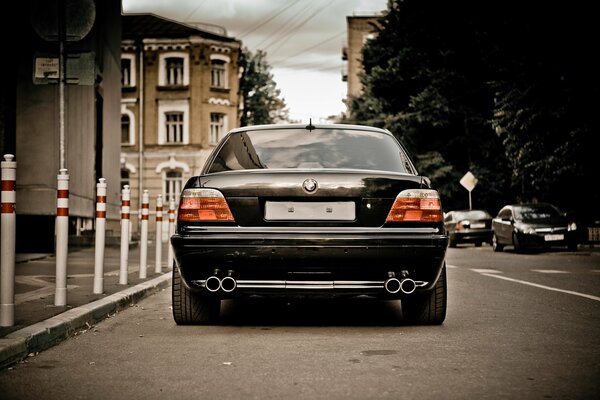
(171, 265, 221, 325)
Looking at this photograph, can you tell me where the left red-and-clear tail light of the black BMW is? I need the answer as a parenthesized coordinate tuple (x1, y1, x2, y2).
(177, 189, 234, 221)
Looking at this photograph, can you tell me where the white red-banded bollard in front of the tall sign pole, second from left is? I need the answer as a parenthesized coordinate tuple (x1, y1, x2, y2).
(54, 168, 69, 306)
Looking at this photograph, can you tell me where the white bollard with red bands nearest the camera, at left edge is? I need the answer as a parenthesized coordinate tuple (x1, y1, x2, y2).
(0, 154, 17, 326)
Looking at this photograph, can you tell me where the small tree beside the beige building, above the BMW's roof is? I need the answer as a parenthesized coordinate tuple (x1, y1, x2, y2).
(240, 48, 288, 126)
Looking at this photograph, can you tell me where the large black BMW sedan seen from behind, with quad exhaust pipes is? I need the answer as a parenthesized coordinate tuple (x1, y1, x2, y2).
(171, 124, 448, 324)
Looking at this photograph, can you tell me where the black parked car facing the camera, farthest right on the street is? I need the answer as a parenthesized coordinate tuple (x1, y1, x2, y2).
(492, 203, 578, 251)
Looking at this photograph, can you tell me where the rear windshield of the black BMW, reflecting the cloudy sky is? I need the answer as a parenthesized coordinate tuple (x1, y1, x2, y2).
(207, 129, 415, 174)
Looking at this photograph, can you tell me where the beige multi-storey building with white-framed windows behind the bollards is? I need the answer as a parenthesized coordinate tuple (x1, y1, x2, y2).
(120, 15, 241, 240)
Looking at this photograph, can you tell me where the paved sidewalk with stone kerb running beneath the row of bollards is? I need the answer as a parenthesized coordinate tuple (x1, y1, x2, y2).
(0, 243, 172, 368)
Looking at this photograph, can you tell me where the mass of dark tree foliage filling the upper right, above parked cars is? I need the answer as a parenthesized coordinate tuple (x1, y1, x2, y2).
(348, 0, 600, 213)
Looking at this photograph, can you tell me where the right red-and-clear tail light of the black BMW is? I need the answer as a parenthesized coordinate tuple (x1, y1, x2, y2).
(385, 189, 444, 222)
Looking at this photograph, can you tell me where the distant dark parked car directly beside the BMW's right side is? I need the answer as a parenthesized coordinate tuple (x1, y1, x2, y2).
(444, 210, 492, 247)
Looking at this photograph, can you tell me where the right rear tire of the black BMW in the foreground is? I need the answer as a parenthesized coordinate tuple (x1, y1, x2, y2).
(401, 262, 448, 325)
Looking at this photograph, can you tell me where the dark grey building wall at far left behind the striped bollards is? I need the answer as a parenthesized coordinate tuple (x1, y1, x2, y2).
(0, 0, 121, 253)
